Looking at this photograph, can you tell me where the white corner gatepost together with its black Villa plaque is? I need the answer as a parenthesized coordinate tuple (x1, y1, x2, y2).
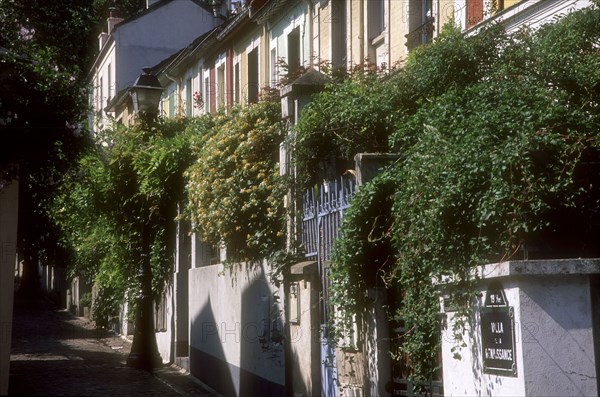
(440, 259, 600, 396)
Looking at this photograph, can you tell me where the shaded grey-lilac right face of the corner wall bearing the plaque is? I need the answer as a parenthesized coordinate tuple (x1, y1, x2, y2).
(519, 275, 597, 396)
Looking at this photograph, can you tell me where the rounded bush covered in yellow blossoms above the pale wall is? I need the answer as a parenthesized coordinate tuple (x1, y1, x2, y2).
(186, 91, 285, 260)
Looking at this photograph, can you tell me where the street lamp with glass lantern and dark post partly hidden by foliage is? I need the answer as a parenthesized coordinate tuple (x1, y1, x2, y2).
(127, 73, 162, 371)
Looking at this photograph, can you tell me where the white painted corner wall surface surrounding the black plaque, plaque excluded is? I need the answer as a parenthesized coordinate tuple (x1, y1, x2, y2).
(442, 260, 600, 396)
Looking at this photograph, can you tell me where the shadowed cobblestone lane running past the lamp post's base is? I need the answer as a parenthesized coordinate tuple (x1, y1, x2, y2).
(9, 297, 216, 397)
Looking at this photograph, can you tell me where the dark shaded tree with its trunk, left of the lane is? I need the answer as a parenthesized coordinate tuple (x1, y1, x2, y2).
(0, 0, 143, 292)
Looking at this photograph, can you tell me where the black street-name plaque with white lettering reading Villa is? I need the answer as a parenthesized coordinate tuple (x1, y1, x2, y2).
(480, 284, 517, 376)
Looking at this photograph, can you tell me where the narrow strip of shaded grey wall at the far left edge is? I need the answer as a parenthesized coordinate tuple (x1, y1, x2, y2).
(0, 181, 19, 395)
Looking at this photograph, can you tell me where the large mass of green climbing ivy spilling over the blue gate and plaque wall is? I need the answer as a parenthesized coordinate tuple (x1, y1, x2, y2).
(304, 9, 600, 378)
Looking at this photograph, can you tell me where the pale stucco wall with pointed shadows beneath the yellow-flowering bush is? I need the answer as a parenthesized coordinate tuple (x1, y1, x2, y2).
(189, 263, 285, 396)
